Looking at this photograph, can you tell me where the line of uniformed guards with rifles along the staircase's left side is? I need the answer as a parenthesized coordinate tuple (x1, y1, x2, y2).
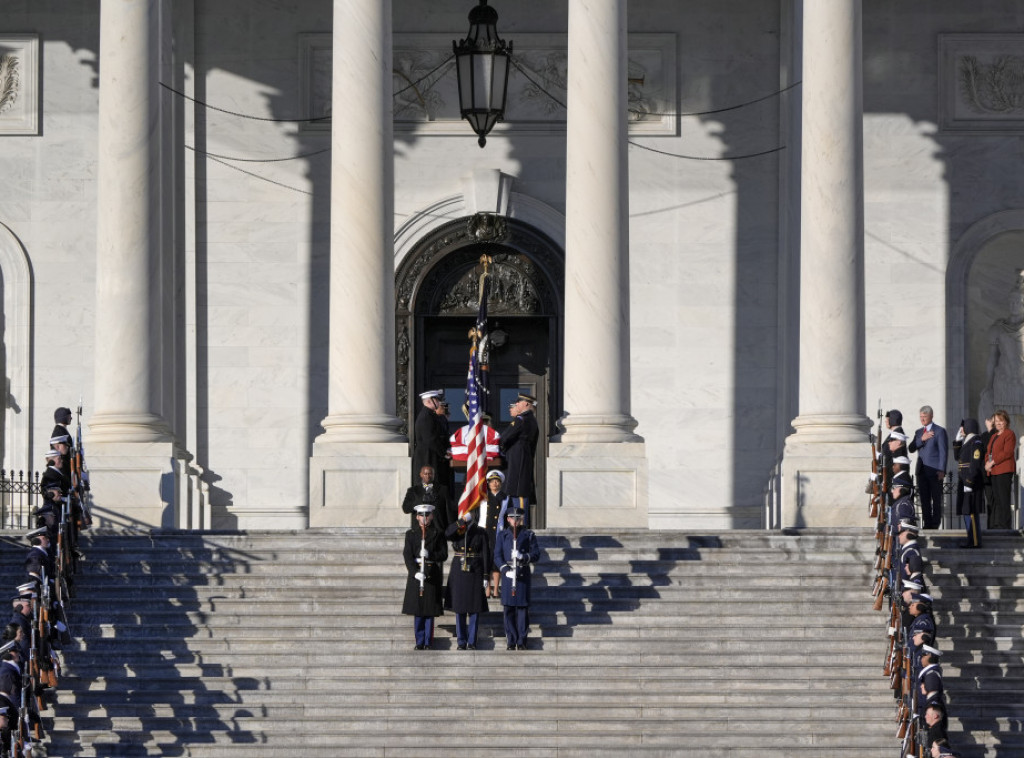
(0, 406, 91, 758)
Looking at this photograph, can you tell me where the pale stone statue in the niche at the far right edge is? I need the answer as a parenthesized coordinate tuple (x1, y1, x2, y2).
(978, 268, 1024, 426)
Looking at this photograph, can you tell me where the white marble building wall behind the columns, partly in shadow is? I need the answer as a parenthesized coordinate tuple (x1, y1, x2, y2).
(0, 0, 1024, 529)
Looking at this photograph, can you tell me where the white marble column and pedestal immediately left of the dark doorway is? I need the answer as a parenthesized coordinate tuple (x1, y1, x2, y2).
(309, 0, 409, 525)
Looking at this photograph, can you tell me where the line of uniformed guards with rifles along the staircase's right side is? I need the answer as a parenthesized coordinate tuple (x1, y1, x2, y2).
(868, 410, 963, 758)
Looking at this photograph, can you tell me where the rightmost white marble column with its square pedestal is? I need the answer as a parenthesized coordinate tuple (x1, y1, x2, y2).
(783, 0, 870, 527)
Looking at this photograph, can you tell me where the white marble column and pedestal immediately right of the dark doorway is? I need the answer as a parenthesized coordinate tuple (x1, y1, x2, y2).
(547, 0, 646, 525)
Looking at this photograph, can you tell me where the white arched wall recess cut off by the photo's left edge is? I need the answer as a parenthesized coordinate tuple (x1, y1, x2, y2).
(0, 221, 33, 471)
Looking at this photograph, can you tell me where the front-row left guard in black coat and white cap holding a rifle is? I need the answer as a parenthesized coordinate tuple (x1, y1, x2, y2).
(401, 503, 447, 650)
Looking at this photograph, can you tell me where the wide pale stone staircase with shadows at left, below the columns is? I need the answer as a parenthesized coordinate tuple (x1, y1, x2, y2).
(0, 529, 1024, 758)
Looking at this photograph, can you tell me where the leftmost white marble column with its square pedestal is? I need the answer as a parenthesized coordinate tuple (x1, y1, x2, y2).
(88, 0, 186, 527)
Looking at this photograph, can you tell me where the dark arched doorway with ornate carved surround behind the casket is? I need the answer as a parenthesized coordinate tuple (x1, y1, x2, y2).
(395, 214, 564, 527)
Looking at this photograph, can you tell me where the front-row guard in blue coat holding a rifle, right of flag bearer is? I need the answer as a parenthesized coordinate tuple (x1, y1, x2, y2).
(495, 503, 541, 650)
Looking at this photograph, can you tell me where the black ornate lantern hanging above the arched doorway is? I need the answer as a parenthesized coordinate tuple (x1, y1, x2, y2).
(452, 0, 512, 148)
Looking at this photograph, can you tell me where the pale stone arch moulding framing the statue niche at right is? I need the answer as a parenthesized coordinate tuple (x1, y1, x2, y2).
(946, 209, 1024, 424)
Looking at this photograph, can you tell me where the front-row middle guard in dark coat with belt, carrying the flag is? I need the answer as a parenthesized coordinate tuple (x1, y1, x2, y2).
(444, 511, 492, 650)
